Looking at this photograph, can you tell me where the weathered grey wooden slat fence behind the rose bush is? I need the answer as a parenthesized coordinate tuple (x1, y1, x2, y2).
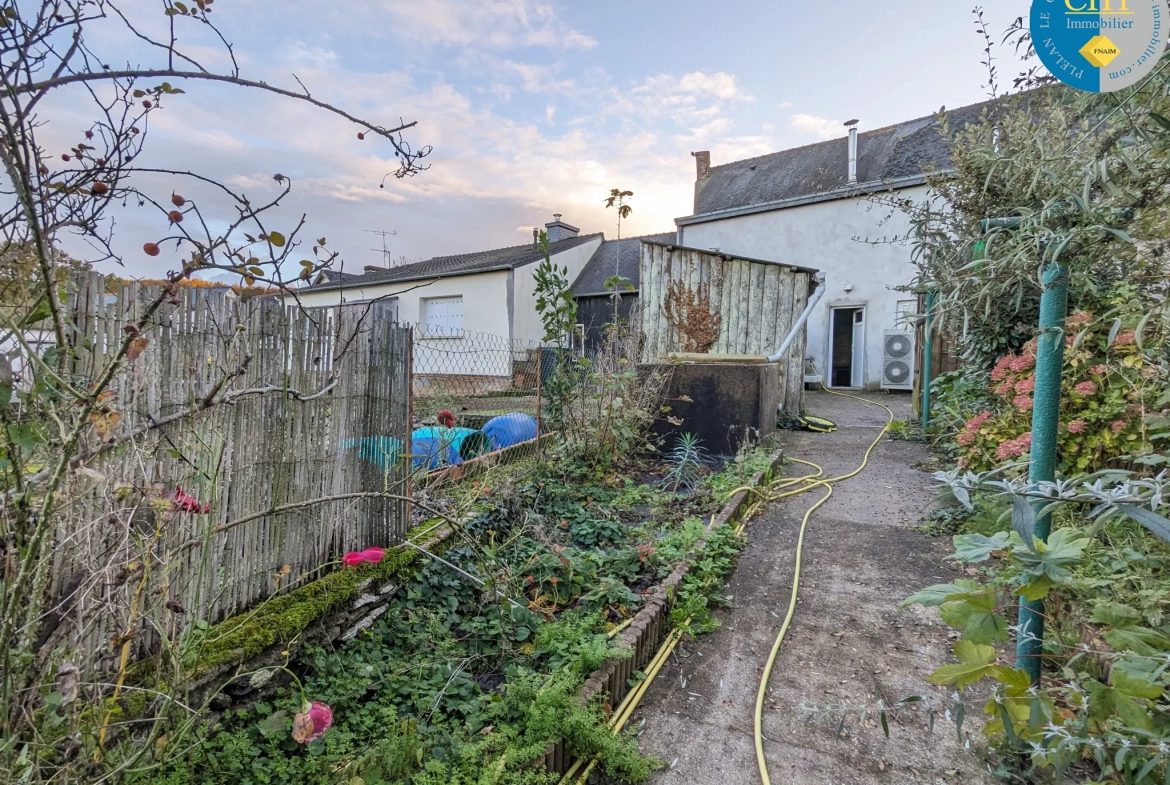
(50, 274, 412, 670)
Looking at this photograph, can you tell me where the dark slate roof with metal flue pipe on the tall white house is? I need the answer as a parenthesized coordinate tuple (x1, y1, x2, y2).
(680, 102, 996, 222)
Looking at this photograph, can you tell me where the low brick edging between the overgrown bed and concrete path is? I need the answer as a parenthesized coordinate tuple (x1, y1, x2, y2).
(544, 448, 784, 774)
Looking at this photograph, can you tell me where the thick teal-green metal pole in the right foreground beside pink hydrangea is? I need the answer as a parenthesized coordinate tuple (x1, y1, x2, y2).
(1016, 264, 1068, 683)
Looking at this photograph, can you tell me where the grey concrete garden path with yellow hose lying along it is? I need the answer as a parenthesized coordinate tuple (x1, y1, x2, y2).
(631, 393, 997, 785)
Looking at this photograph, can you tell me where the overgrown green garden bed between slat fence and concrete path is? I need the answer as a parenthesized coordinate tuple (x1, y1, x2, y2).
(116, 448, 772, 785)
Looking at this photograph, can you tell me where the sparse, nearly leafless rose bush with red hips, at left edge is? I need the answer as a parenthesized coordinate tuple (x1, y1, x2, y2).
(0, 0, 429, 781)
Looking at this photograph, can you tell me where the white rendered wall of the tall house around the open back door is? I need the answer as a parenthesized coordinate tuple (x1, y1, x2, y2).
(679, 187, 927, 388)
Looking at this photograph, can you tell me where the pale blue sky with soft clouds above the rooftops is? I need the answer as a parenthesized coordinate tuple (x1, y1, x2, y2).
(64, 0, 1027, 276)
